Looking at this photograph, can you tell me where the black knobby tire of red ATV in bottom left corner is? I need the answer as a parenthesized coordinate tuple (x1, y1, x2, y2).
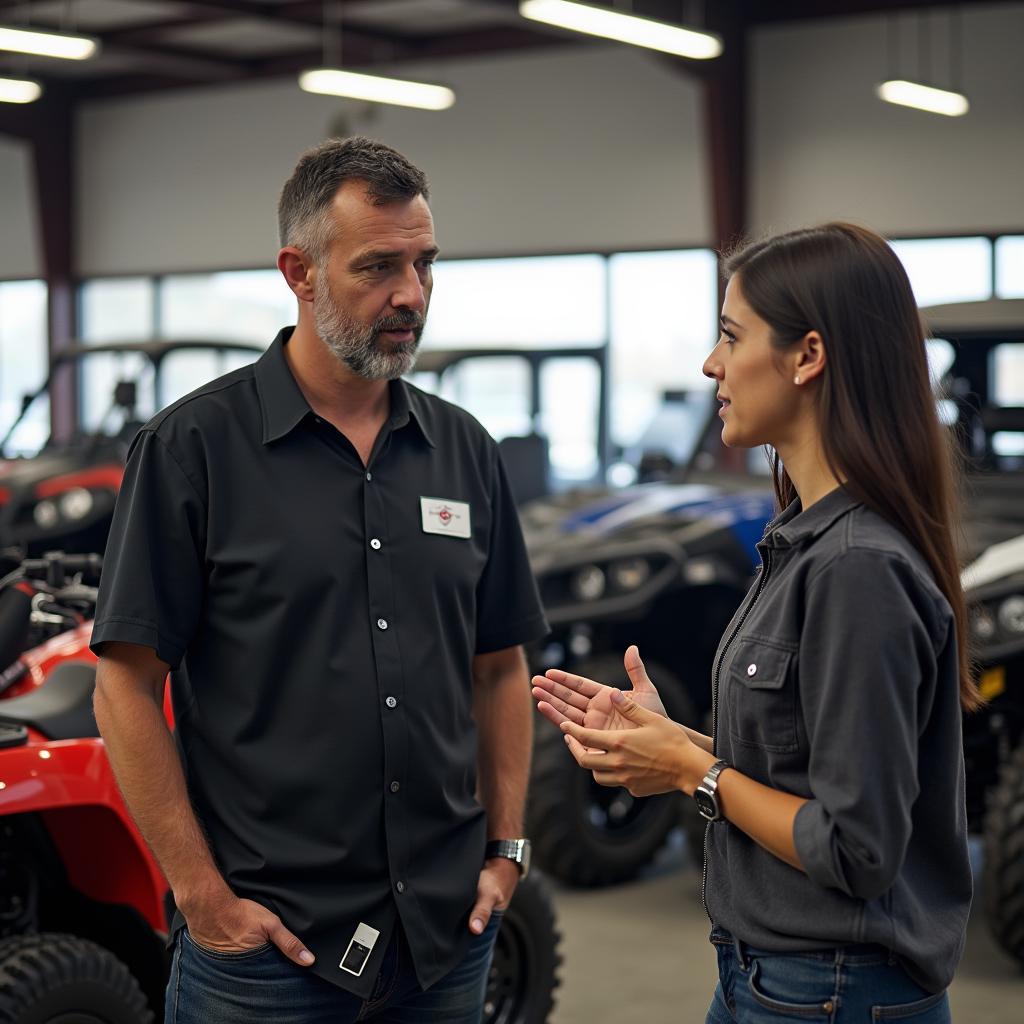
(0, 933, 153, 1024)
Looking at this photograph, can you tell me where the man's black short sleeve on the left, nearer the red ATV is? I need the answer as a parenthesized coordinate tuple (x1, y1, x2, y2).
(91, 430, 206, 669)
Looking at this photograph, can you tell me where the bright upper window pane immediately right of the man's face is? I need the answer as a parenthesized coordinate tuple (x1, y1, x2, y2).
(423, 256, 606, 348)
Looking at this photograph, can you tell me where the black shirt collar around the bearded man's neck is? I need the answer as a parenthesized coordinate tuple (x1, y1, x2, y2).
(255, 327, 436, 447)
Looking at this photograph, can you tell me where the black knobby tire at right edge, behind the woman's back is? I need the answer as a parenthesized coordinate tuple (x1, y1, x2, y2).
(984, 744, 1024, 965)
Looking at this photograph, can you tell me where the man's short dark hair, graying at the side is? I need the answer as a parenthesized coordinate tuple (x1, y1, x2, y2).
(278, 135, 430, 265)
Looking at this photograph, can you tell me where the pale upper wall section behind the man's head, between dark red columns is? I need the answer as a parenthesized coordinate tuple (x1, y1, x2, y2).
(78, 47, 711, 275)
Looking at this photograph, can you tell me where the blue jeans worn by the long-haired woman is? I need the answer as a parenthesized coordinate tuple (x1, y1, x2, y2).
(706, 928, 951, 1024)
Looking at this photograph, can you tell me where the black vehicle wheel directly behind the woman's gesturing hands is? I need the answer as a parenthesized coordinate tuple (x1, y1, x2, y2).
(526, 655, 695, 886)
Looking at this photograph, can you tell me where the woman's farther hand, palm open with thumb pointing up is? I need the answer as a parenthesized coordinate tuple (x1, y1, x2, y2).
(532, 645, 669, 741)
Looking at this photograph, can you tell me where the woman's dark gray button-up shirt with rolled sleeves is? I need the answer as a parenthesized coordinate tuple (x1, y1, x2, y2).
(706, 487, 972, 991)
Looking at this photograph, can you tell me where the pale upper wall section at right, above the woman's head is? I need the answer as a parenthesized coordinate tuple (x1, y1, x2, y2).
(751, 4, 1024, 236)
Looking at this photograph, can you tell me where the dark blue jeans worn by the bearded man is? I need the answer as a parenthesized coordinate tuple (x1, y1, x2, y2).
(165, 913, 501, 1024)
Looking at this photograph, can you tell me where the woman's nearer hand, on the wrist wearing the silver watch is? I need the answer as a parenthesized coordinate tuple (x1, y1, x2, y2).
(560, 689, 715, 797)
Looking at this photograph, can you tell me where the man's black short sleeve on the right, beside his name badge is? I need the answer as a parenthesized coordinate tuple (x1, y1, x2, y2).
(476, 449, 550, 654)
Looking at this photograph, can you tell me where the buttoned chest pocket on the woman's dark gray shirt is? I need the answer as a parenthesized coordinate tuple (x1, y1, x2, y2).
(729, 637, 798, 754)
